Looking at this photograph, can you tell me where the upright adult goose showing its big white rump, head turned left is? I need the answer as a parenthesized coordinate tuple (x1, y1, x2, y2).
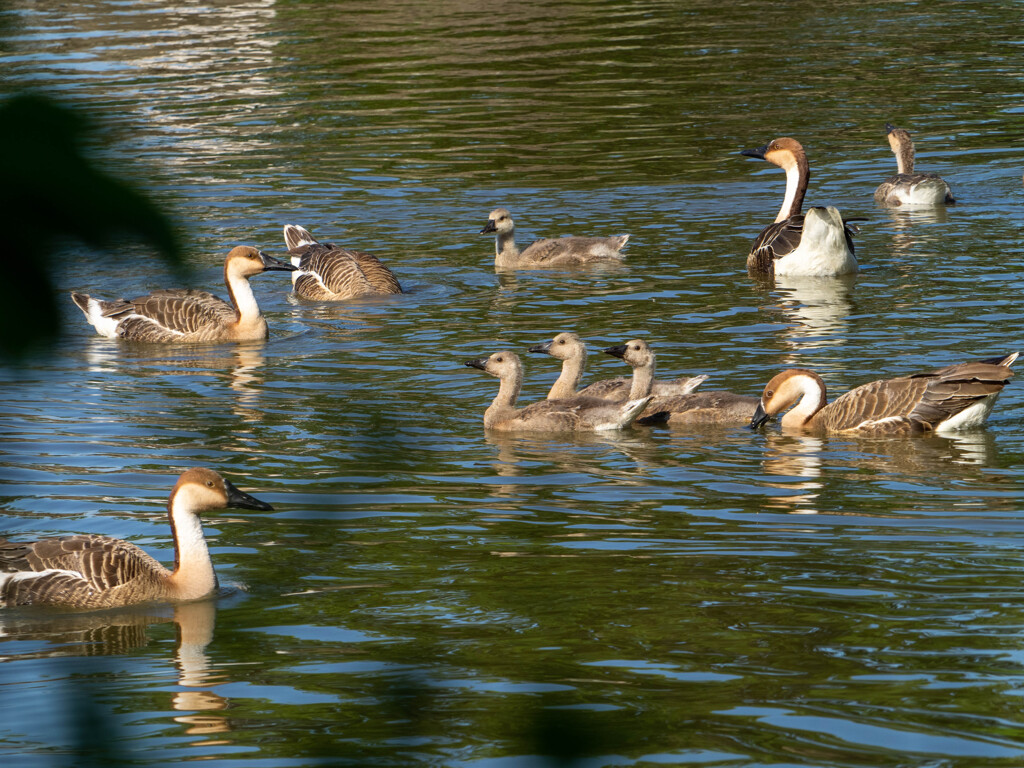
(739, 137, 857, 278)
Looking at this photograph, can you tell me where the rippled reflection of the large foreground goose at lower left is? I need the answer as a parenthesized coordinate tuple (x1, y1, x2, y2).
(0, 600, 229, 734)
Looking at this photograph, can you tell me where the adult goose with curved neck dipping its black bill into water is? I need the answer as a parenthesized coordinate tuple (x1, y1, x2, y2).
(751, 352, 1017, 436)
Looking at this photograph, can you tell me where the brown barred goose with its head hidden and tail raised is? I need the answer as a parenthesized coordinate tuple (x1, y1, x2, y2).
(285, 224, 401, 301)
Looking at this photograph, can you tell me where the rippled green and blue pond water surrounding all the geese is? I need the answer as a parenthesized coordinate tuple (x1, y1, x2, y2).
(0, 0, 1024, 768)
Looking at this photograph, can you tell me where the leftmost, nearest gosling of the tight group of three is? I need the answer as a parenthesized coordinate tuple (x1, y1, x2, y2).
(464, 352, 650, 432)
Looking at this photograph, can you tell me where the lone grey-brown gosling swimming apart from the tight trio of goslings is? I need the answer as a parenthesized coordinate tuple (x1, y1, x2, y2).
(480, 208, 630, 269)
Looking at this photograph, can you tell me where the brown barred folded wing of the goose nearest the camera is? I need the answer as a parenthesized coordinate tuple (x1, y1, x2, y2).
(0, 535, 167, 607)
